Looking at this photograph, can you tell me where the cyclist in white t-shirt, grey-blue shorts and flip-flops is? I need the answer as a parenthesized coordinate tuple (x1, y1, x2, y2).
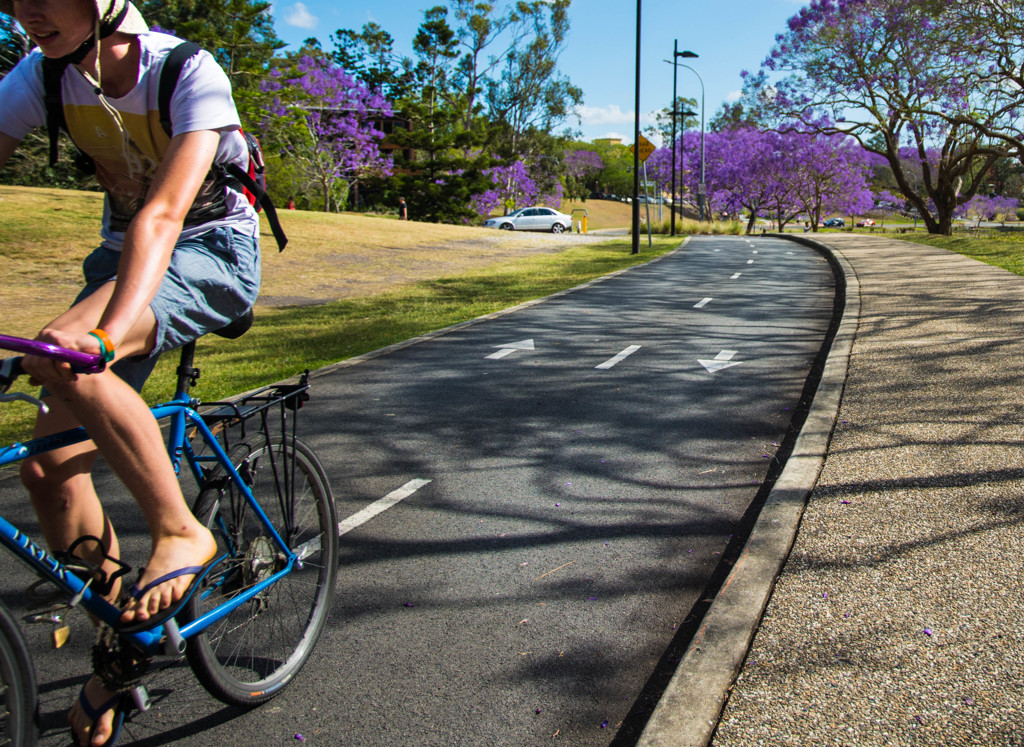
(0, 0, 260, 745)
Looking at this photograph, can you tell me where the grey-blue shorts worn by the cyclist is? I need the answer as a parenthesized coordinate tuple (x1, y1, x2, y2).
(75, 227, 260, 390)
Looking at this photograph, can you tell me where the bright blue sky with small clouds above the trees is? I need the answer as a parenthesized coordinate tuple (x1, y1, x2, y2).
(272, 0, 806, 142)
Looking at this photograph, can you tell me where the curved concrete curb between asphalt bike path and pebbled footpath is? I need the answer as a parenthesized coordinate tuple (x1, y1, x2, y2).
(637, 235, 860, 747)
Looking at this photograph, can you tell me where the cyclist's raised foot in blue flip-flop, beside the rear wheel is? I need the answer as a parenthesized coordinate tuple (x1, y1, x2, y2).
(121, 527, 217, 625)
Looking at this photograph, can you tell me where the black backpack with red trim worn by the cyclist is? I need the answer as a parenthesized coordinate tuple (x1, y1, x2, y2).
(43, 42, 288, 251)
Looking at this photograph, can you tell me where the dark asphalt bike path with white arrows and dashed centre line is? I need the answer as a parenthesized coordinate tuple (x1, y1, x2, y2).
(0, 238, 835, 745)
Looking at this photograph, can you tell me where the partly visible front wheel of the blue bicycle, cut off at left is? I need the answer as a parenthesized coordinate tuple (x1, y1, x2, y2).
(0, 604, 38, 747)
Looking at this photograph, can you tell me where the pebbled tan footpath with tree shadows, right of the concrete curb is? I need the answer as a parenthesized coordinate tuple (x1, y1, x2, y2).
(712, 235, 1024, 747)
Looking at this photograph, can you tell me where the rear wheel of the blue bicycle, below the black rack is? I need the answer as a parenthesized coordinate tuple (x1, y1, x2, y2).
(183, 440, 338, 707)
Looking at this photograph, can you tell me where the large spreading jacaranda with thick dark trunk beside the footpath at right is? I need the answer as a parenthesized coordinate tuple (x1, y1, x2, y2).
(744, 0, 1012, 234)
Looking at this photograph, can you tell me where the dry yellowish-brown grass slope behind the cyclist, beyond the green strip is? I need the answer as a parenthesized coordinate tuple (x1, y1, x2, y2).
(0, 185, 614, 337)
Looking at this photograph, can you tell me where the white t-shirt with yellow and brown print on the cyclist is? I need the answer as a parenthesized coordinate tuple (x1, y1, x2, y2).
(0, 32, 259, 250)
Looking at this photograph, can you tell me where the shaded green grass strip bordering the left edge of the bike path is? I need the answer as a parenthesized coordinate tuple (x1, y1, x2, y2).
(0, 237, 682, 443)
